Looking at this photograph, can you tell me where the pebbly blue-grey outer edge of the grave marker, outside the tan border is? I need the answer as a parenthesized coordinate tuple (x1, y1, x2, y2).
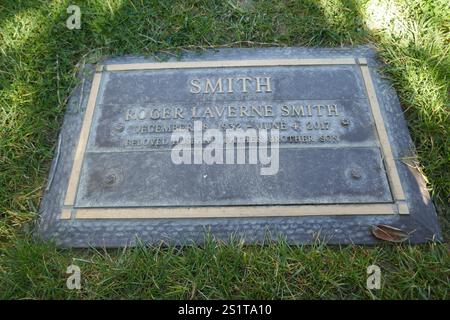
(35, 46, 441, 247)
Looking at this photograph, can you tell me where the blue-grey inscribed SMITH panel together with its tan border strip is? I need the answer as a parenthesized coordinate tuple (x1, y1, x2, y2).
(61, 58, 409, 219)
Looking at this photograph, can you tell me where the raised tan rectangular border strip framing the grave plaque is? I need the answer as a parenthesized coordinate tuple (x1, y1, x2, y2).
(60, 58, 409, 219)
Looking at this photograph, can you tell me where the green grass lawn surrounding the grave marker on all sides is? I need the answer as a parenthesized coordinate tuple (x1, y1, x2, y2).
(0, 0, 450, 299)
